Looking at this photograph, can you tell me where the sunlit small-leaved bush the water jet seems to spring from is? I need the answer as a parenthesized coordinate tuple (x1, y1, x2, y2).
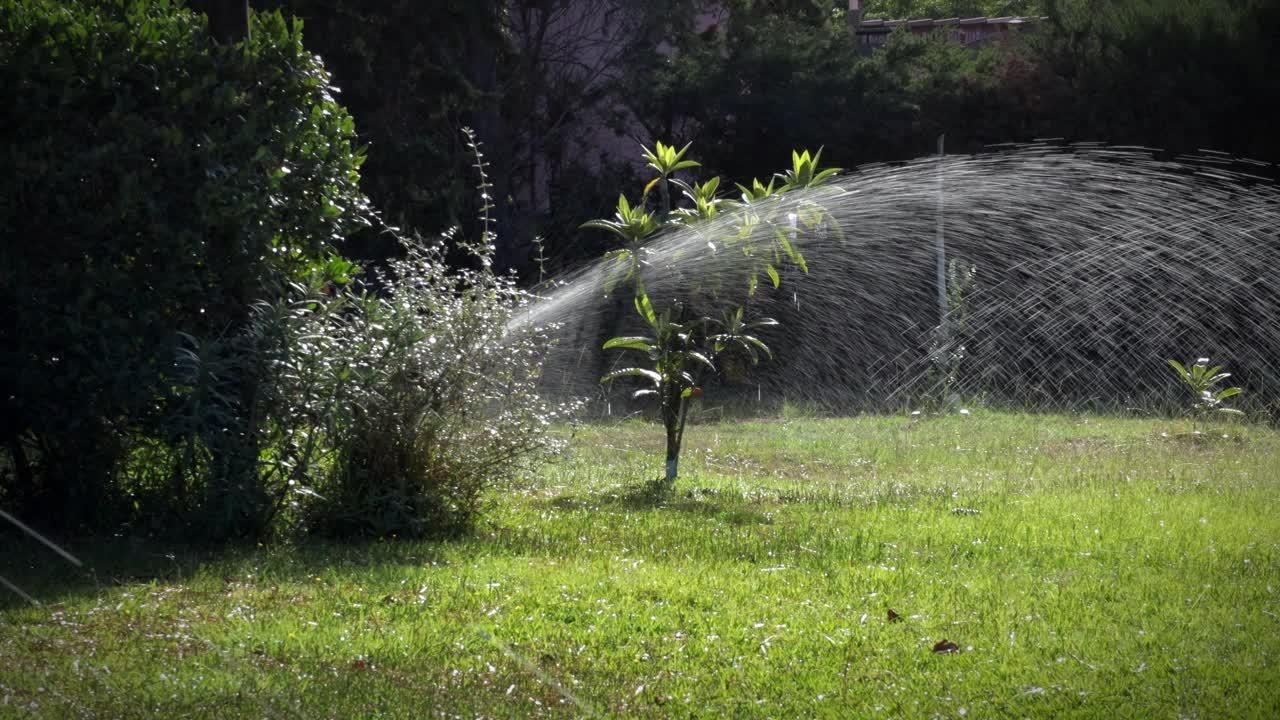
(305, 242, 573, 536)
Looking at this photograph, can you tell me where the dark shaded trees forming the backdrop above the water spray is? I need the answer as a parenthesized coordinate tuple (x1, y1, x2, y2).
(227, 0, 1280, 278)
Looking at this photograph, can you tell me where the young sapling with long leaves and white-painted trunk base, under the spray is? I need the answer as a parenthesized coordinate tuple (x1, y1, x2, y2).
(582, 142, 838, 487)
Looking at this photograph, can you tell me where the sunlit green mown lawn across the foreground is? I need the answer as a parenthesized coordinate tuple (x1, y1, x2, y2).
(0, 413, 1280, 717)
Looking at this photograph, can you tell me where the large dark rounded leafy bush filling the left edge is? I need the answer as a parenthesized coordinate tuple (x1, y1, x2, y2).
(0, 0, 367, 533)
